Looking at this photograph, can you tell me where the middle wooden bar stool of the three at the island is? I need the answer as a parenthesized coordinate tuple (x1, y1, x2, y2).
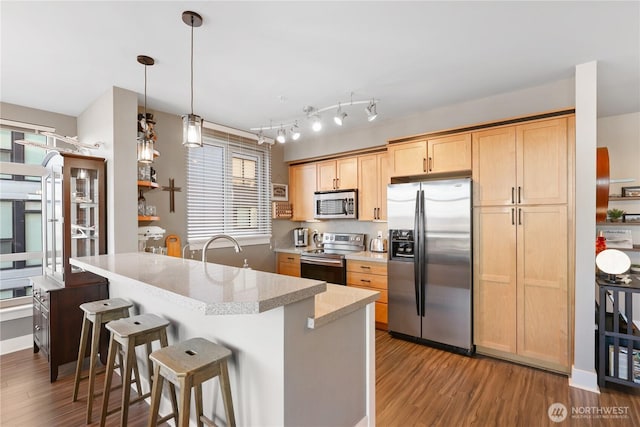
(100, 314, 176, 426)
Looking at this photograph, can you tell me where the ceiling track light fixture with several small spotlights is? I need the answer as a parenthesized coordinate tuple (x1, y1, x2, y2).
(251, 93, 379, 143)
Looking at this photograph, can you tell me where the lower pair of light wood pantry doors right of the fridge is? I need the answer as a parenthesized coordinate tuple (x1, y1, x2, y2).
(474, 205, 570, 372)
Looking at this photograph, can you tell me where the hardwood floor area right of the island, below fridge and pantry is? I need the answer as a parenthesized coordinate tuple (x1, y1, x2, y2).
(376, 331, 640, 427)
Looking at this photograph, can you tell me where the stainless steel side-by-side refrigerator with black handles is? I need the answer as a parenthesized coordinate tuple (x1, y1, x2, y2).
(387, 178, 475, 354)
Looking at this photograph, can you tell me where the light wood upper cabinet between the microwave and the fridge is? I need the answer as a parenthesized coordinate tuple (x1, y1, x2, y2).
(358, 153, 389, 221)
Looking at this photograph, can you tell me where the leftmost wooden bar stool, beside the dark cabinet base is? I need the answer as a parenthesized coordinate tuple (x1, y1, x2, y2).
(71, 298, 134, 424)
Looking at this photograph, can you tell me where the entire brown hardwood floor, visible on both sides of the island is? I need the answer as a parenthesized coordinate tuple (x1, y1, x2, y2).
(0, 331, 640, 427)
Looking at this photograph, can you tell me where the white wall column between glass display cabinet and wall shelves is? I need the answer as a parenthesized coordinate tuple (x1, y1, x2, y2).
(78, 87, 138, 253)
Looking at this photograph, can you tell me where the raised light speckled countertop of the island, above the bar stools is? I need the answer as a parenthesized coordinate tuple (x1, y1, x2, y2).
(70, 252, 327, 315)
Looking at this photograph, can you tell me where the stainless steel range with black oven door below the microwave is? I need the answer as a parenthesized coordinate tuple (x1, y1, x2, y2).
(300, 233, 365, 285)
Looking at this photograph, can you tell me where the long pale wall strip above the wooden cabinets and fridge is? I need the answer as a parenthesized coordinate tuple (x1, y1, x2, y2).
(284, 79, 575, 161)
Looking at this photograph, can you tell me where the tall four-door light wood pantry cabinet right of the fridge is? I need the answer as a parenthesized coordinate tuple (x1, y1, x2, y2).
(472, 115, 575, 372)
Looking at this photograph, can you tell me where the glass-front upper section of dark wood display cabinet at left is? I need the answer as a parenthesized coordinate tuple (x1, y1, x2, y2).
(42, 152, 107, 286)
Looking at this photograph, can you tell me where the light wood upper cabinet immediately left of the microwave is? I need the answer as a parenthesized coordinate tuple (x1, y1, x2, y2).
(289, 163, 316, 221)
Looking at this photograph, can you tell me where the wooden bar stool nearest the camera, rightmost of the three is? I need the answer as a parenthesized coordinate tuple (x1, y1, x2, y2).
(148, 338, 236, 427)
